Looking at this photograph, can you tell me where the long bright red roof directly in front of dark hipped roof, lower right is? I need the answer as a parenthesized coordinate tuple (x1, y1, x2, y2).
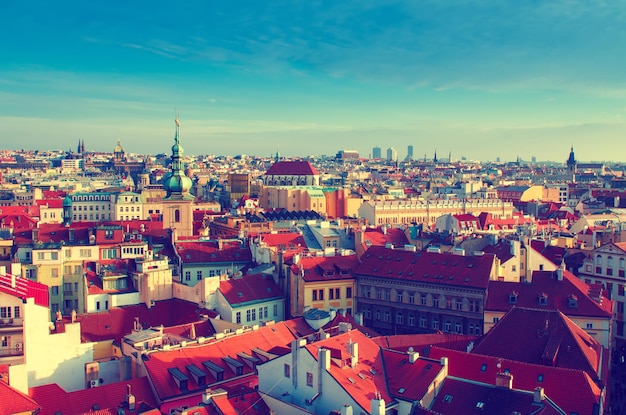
(429, 347, 601, 415)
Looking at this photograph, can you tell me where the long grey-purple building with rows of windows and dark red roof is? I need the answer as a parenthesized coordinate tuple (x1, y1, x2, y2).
(355, 246, 496, 335)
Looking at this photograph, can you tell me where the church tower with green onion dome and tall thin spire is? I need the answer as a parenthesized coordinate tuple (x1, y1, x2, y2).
(162, 116, 194, 236)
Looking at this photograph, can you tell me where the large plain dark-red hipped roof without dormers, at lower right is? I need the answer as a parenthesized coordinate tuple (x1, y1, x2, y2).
(472, 307, 602, 379)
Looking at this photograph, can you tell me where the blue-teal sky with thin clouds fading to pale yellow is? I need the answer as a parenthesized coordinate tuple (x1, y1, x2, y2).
(0, 0, 626, 161)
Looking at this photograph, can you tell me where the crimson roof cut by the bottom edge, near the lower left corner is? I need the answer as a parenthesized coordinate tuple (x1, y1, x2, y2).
(28, 377, 157, 415)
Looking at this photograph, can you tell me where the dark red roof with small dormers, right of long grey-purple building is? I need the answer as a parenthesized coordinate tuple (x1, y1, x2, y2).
(485, 270, 613, 319)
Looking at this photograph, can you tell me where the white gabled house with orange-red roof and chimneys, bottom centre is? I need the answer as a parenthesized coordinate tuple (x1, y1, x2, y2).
(258, 330, 448, 415)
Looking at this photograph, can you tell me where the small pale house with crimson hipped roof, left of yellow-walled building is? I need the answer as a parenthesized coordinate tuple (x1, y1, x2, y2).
(216, 274, 285, 326)
